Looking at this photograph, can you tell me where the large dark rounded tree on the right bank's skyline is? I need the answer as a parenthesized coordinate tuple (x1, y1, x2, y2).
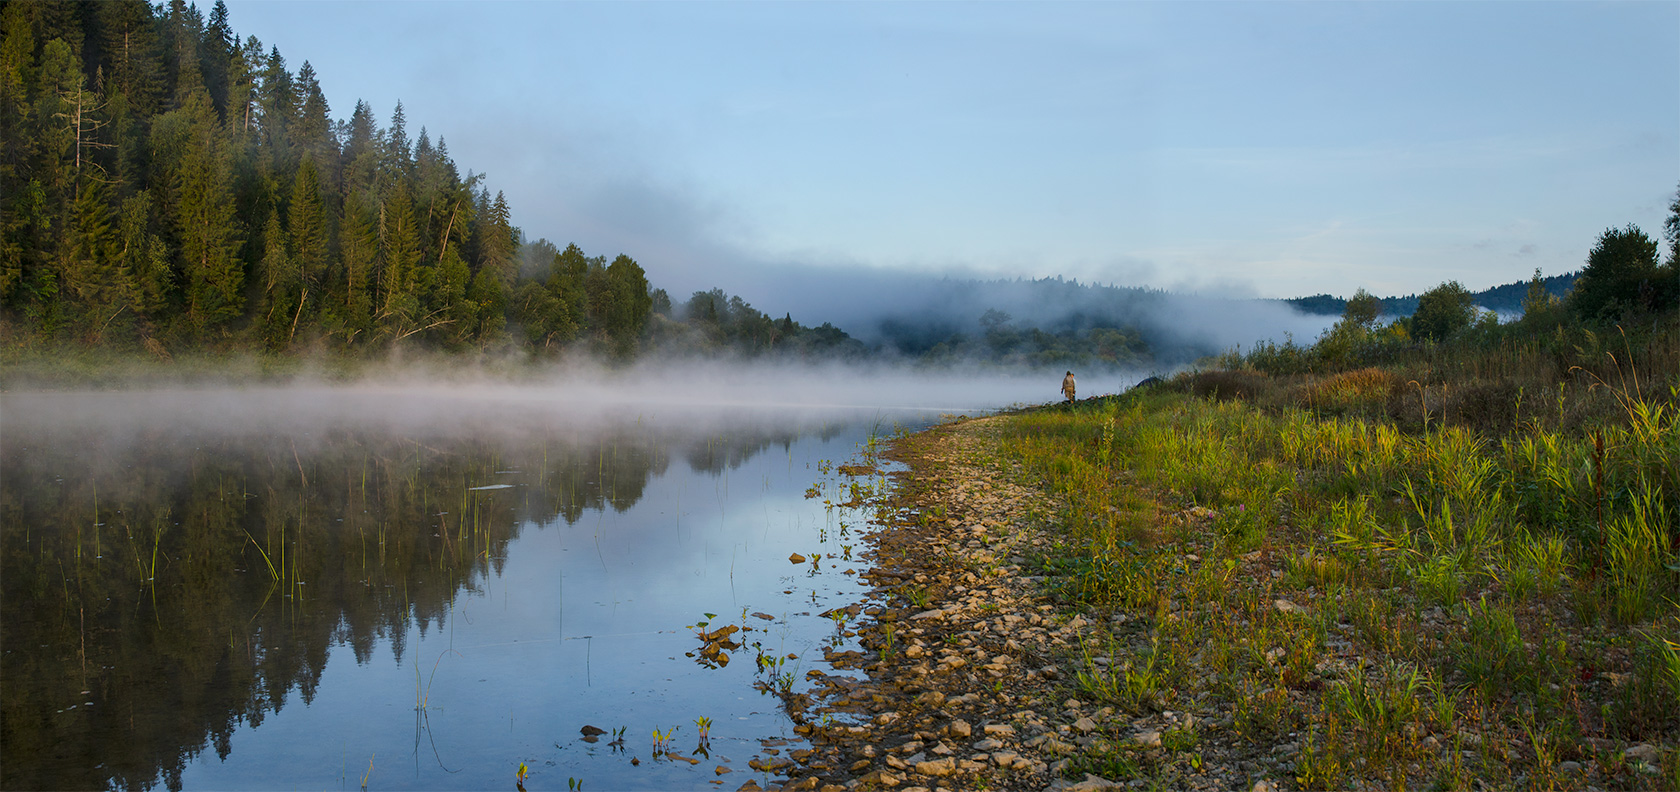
(1569, 224, 1670, 321)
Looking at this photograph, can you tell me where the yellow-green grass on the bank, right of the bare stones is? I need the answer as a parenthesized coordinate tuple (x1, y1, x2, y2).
(1000, 361, 1680, 789)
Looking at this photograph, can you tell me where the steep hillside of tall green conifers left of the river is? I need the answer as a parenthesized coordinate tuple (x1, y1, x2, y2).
(0, 0, 855, 363)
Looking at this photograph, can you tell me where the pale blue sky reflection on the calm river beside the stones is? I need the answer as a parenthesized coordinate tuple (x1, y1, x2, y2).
(170, 412, 900, 789)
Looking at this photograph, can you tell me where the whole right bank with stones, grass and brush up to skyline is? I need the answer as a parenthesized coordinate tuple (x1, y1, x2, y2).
(769, 270, 1680, 790)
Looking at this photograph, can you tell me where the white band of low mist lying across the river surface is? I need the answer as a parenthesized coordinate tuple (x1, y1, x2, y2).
(0, 362, 1146, 452)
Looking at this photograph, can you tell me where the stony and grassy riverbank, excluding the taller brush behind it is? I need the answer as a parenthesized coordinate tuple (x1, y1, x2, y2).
(766, 386, 1680, 790)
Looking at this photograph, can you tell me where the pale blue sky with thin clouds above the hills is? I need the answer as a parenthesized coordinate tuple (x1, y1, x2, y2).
(228, 0, 1680, 313)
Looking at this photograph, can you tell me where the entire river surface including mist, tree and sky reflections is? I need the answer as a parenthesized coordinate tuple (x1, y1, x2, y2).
(0, 370, 1137, 790)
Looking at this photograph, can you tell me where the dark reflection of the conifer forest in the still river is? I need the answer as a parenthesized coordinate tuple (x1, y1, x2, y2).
(0, 418, 813, 789)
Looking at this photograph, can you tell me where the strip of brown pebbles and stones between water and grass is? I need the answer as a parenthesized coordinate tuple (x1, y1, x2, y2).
(756, 417, 1268, 792)
